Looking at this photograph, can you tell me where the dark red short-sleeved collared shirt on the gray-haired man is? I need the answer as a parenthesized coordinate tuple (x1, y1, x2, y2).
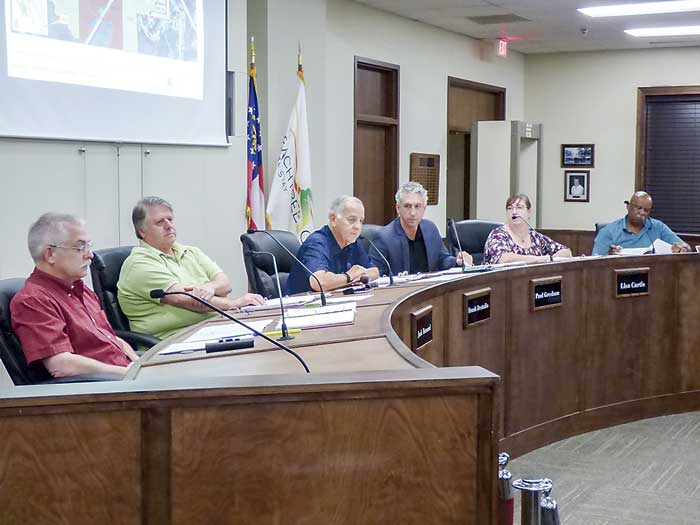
(10, 268, 131, 366)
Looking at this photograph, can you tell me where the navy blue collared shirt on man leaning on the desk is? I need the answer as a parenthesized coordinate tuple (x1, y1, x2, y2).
(287, 225, 375, 294)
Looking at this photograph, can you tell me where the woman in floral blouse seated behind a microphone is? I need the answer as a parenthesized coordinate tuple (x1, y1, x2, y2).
(484, 193, 571, 264)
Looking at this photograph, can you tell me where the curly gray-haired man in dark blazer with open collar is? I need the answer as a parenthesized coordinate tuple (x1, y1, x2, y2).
(370, 182, 472, 275)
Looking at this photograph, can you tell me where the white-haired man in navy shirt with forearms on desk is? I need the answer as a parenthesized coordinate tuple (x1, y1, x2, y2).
(287, 195, 379, 294)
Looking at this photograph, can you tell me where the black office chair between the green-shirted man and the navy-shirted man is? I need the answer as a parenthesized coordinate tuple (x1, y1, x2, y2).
(241, 230, 301, 299)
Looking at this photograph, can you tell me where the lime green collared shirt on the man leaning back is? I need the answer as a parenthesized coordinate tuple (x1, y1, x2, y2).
(117, 241, 221, 339)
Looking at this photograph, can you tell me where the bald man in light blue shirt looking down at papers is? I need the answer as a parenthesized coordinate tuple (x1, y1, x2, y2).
(593, 191, 690, 255)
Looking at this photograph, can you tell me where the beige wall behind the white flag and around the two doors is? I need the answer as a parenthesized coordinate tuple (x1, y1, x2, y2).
(248, 0, 524, 233)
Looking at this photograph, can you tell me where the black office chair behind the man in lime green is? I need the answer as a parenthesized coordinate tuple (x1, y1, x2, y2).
(90, 246, 160, 348)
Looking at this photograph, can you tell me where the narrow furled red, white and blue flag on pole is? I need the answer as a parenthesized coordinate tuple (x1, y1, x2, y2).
(245, 64, 267, 230)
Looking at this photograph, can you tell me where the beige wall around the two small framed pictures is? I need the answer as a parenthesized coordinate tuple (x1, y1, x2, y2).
(525, 47, 700, 230)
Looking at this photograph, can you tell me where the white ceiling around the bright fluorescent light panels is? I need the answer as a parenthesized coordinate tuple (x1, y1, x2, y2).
(356, 0, 700, 53)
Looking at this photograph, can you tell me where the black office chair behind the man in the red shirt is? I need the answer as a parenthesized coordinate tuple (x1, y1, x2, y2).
(0, 278, 121, 386)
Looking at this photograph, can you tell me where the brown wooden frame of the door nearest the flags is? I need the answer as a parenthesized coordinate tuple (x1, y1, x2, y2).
(352, 55, 401, 223)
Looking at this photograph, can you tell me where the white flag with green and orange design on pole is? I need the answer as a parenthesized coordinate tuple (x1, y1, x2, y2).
(267, 54, 314, 242)
